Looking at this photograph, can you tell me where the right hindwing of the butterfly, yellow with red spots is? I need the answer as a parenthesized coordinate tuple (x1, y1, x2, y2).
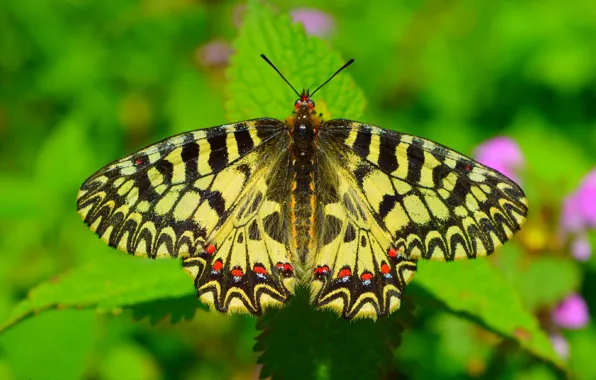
(311, 153, 416, 319)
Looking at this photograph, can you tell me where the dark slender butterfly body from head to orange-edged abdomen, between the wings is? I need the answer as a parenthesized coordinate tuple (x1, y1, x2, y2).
(288, 92, 321, 262)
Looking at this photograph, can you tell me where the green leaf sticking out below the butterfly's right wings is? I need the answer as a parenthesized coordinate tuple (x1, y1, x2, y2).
(414, 251, 564, 368)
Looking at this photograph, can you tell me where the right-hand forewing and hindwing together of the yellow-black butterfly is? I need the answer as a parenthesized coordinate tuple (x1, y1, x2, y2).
(311, 120, 527, 318)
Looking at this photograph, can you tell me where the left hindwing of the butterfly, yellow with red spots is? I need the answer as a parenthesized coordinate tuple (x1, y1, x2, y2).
(184, 149, 294, 314)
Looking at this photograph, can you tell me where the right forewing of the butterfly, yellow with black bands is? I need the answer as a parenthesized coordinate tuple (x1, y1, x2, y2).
(320, 120, 527, 261)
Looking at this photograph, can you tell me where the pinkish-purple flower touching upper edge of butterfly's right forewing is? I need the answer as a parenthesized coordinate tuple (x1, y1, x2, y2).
(474, 136, 525, 183)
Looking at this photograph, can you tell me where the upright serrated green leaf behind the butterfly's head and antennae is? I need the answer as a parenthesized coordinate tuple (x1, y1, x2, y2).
(226, 0, 365, 121)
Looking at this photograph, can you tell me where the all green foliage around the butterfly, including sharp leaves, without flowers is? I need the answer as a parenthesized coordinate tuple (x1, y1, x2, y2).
(0, 0, 596, 379)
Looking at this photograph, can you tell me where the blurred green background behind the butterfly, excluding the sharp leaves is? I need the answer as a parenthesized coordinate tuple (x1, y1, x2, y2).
(0, 0, 596, 379)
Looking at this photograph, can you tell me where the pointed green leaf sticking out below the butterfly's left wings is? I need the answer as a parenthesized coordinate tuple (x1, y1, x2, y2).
(0, 253, 199, 331)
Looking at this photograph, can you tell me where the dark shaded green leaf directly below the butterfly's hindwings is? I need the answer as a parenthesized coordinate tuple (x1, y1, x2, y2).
(255, 289, 413, 379)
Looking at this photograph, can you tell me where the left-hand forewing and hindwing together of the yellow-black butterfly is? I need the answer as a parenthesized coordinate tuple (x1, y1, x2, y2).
(77, 119, 291, 313)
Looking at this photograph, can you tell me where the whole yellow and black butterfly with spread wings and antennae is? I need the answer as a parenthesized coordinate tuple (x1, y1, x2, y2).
(77, 55, 528, 319)
